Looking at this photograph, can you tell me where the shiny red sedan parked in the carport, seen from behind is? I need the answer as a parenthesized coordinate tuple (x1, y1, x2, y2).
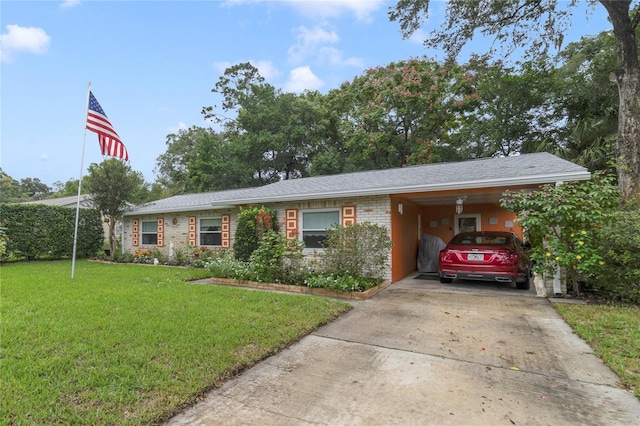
(438, 231, 531, 290)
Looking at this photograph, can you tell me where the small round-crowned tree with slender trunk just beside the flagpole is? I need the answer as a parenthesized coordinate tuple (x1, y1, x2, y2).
(83, 158, 145, 258)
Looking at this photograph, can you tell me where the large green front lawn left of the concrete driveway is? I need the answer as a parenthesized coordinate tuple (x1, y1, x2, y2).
(0, 261, 349, 425)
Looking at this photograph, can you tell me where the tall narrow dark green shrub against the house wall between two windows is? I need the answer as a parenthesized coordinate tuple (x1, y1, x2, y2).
(233, 207, 278, 262)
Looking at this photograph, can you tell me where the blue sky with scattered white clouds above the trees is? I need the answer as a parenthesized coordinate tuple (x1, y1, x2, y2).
(0, 0, 611, 185)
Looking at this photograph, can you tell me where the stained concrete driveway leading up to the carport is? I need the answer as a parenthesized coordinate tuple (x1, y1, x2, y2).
(168, 278, 640, 426)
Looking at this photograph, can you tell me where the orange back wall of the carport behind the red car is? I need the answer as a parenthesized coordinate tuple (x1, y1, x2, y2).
(420, 204, 522, 243)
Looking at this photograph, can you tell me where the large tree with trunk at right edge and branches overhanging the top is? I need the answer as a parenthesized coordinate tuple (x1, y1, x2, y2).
(389, 0, 640, 202)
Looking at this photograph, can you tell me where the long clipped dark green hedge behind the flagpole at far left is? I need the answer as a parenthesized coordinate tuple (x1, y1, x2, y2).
(0, 204, 104, 260)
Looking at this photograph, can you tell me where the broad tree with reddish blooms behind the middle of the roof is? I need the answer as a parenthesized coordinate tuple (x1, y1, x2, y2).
(331, 58, 486, 170)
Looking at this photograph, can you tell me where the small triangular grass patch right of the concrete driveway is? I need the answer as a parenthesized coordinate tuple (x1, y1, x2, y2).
(554, 303, 640, 399)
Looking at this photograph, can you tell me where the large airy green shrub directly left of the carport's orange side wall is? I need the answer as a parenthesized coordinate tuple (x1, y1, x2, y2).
(320, 222, 392, 279)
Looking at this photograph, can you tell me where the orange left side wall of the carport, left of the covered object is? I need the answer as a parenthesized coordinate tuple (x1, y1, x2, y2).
(391, 197, 420, 282)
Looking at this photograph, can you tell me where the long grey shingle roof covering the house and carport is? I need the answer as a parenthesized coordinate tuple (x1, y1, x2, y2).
(125, 152, 590, 215)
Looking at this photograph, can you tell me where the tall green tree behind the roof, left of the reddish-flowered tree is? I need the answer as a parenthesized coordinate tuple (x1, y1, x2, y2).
(202, 63, 326, 184)
